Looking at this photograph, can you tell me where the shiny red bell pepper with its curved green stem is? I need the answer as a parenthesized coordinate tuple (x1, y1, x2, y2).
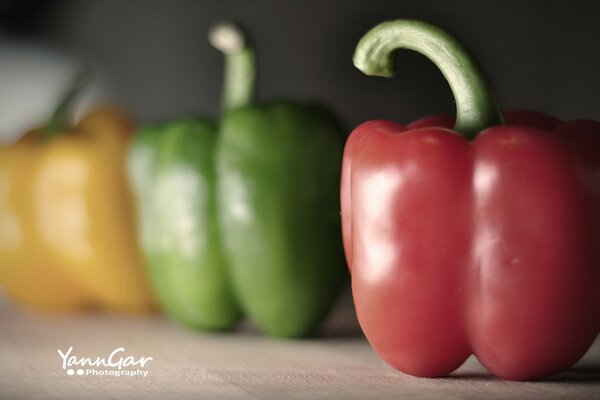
(341, 20, 600, 380)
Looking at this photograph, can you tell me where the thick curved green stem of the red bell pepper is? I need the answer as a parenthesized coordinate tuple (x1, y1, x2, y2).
(353, 20, 504, 139)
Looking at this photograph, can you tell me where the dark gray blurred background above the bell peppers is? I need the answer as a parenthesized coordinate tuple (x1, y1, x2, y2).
(0, 0, 600, 129)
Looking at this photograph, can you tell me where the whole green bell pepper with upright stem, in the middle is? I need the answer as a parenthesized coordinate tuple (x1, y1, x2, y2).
(128, 23, 345, 337)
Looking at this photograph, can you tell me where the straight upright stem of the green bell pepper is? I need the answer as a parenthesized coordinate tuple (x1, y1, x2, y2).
(209, 21, 256, 112)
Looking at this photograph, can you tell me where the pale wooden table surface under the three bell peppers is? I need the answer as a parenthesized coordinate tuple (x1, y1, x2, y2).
(0, 290, 600, 400)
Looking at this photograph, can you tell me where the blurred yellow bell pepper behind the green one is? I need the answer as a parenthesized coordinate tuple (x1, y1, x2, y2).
(0, 79, 153, 311)
